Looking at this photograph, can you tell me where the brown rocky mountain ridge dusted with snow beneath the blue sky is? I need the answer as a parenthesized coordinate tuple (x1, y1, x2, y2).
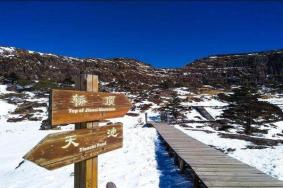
(0, 47, 283, 90)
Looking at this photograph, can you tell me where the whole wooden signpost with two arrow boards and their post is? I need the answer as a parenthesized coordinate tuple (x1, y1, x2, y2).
(24, 74, 131, 188)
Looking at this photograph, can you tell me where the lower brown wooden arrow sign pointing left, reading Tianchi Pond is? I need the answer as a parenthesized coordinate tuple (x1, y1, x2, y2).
(24, 123, 123, 170)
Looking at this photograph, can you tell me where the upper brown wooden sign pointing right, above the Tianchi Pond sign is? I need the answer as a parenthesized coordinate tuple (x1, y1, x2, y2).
(50, 90, 131, 125)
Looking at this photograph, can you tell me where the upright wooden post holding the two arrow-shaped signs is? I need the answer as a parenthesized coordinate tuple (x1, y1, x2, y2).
(74, 74, 98, 188)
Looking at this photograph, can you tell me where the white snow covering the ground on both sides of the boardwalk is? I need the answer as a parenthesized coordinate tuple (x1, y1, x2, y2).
(0, 85, 283, 188)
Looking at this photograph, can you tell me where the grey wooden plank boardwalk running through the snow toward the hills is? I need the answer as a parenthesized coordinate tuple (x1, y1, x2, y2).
(154, 122, 283, 188)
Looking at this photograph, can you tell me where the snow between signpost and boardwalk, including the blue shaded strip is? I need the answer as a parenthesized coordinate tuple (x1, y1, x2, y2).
(99, 114, 191, 188)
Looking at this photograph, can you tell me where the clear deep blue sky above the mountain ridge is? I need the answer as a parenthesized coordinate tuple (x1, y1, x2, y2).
(0, 0, 283, 67)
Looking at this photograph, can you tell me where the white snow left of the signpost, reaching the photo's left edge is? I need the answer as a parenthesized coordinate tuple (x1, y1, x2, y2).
(0, 90, 73, 188)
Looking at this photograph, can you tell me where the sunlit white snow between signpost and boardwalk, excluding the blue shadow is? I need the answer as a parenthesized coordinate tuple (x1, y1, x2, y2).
(99, 117, 159, 187)
